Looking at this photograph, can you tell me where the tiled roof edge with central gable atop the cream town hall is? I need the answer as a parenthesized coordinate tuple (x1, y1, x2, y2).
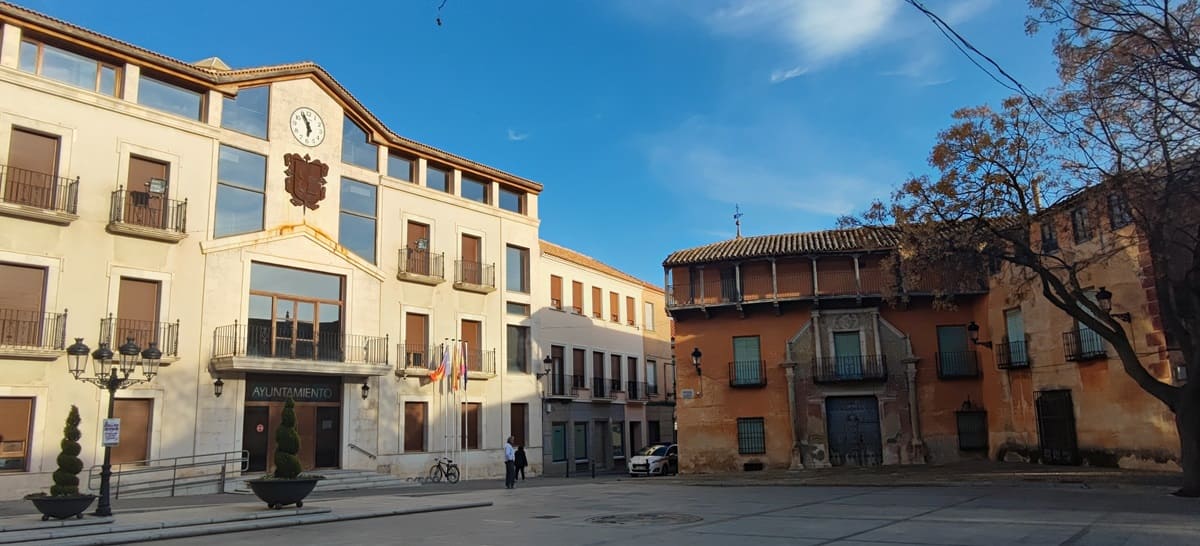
(0, 1, 542, 193)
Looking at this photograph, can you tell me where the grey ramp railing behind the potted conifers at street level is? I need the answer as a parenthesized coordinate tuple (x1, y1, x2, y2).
(88, 450, 250, 498)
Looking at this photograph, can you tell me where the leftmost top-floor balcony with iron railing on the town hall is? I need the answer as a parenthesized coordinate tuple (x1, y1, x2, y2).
(0, 164, 79, 226)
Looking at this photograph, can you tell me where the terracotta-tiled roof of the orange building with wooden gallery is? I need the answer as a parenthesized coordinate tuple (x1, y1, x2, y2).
(662, 228, 898, 268)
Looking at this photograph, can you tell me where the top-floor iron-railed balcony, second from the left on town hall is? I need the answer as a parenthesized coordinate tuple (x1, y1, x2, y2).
(108, 188, 187, 242)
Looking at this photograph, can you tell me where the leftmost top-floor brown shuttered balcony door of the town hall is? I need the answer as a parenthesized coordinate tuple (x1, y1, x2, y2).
(4, 128, 59, 209)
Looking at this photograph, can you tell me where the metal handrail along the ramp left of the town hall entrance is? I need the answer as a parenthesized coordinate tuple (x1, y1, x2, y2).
(88, 450, 250, 498)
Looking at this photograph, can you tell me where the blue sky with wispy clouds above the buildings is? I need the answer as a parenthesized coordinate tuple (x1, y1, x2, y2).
(22, 0, 1055, 284)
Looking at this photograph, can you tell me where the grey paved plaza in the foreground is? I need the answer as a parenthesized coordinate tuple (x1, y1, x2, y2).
(147, 479, 1200, 546)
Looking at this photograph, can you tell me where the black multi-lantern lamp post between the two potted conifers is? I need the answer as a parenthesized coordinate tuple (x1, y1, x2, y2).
(67, 337, 162, 517)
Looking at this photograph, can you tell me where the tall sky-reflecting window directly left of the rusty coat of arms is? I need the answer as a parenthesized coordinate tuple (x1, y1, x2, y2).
(212, 145, 266, 238)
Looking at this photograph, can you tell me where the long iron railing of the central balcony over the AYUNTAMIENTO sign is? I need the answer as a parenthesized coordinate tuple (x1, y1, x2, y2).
(212, 323, 388, 365)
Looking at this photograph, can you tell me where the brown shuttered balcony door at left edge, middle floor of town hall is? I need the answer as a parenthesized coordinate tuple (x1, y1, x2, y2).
(0, 263, 48, 347)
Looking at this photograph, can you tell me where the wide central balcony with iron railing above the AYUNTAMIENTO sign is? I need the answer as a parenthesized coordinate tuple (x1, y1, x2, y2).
(212, 322, 388, 376)
